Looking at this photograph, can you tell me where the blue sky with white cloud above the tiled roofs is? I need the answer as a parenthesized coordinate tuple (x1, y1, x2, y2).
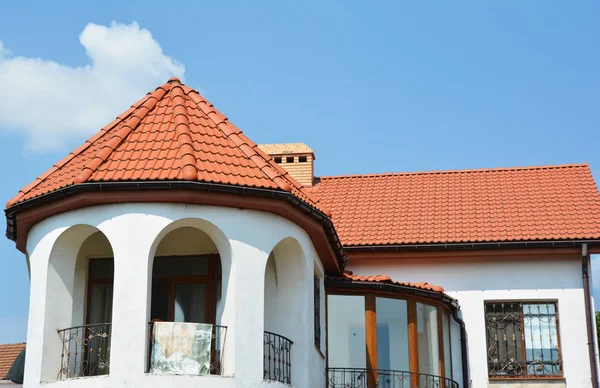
(0, 0, 600, 343)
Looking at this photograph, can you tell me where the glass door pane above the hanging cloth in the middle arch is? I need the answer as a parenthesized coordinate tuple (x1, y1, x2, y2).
(174, 283, 206, 323)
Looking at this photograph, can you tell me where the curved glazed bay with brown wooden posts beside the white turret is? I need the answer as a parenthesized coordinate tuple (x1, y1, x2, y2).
(327, 291, 458, 388)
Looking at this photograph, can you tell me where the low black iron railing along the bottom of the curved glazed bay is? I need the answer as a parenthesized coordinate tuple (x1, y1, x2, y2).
(327, 368, 459, 388)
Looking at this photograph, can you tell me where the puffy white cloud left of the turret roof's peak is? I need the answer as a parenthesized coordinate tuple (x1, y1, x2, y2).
(0, 22, 185, 151)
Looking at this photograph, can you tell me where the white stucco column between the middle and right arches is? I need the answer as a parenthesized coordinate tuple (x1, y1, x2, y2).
(231, 241, 268, 387)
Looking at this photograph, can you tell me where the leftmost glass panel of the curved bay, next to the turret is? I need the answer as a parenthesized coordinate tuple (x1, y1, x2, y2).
(327, 295, 367, 368)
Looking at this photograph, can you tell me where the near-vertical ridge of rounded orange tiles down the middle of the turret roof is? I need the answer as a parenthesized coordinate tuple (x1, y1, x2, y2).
(169, 80, 198, 181)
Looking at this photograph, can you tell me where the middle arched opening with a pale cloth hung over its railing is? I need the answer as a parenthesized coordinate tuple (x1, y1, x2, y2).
(148, 224, 227, 375)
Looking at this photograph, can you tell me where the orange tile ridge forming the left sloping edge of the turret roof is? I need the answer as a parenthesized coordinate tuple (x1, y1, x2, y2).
(6, 90, 164, 208)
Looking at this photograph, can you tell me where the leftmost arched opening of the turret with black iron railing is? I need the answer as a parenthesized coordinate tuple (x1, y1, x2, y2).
(42, 225, 114, 381)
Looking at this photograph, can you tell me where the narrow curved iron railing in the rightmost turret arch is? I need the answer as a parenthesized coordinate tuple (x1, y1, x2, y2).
(263, 331, 293, 385)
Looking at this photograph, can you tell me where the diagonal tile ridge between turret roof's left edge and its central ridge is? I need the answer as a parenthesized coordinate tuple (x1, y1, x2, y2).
(74, 85, 167, 183)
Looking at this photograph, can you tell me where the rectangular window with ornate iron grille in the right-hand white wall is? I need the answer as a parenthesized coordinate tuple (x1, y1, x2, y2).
(485, 301, 562, 377)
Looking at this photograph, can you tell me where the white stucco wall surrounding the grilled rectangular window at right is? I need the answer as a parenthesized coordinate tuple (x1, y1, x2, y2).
(347, 256, 591, 388)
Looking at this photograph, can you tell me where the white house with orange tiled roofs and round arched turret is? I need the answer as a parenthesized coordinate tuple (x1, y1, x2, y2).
(5, 78, 600, 388)
